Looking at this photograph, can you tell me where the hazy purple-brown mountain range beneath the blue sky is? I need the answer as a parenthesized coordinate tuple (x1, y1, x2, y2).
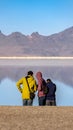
(0, 27, 73, 56)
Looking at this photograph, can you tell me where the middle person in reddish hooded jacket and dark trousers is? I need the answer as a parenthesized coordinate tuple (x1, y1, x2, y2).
(36, 72, 46, 106)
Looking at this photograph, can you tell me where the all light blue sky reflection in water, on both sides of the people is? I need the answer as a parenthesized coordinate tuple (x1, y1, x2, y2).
(0, 78, 73, 106)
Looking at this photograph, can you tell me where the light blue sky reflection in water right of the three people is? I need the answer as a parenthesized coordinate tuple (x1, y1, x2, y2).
(55, 81, 73, 106)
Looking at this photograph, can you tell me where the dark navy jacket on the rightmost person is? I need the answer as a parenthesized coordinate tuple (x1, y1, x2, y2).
(46, 81, 56, 100)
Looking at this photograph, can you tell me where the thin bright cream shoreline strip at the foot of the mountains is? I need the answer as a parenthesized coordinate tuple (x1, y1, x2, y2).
(0, 56, 73, 60)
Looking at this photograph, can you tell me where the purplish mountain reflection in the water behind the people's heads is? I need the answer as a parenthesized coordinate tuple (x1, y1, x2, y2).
(0, 66, 73, 86)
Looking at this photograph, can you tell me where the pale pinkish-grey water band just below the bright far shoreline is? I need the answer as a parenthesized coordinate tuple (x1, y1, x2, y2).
(0, 59, 73, 67)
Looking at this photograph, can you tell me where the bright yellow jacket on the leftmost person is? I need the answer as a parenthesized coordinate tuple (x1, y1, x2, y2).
(16, 75, 37, 99)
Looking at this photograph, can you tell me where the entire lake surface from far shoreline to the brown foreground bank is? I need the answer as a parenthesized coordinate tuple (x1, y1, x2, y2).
(0, 59, 73, 106)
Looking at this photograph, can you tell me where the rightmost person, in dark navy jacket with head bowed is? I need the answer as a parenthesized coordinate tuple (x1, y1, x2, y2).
(46, 79, 56, 106)
